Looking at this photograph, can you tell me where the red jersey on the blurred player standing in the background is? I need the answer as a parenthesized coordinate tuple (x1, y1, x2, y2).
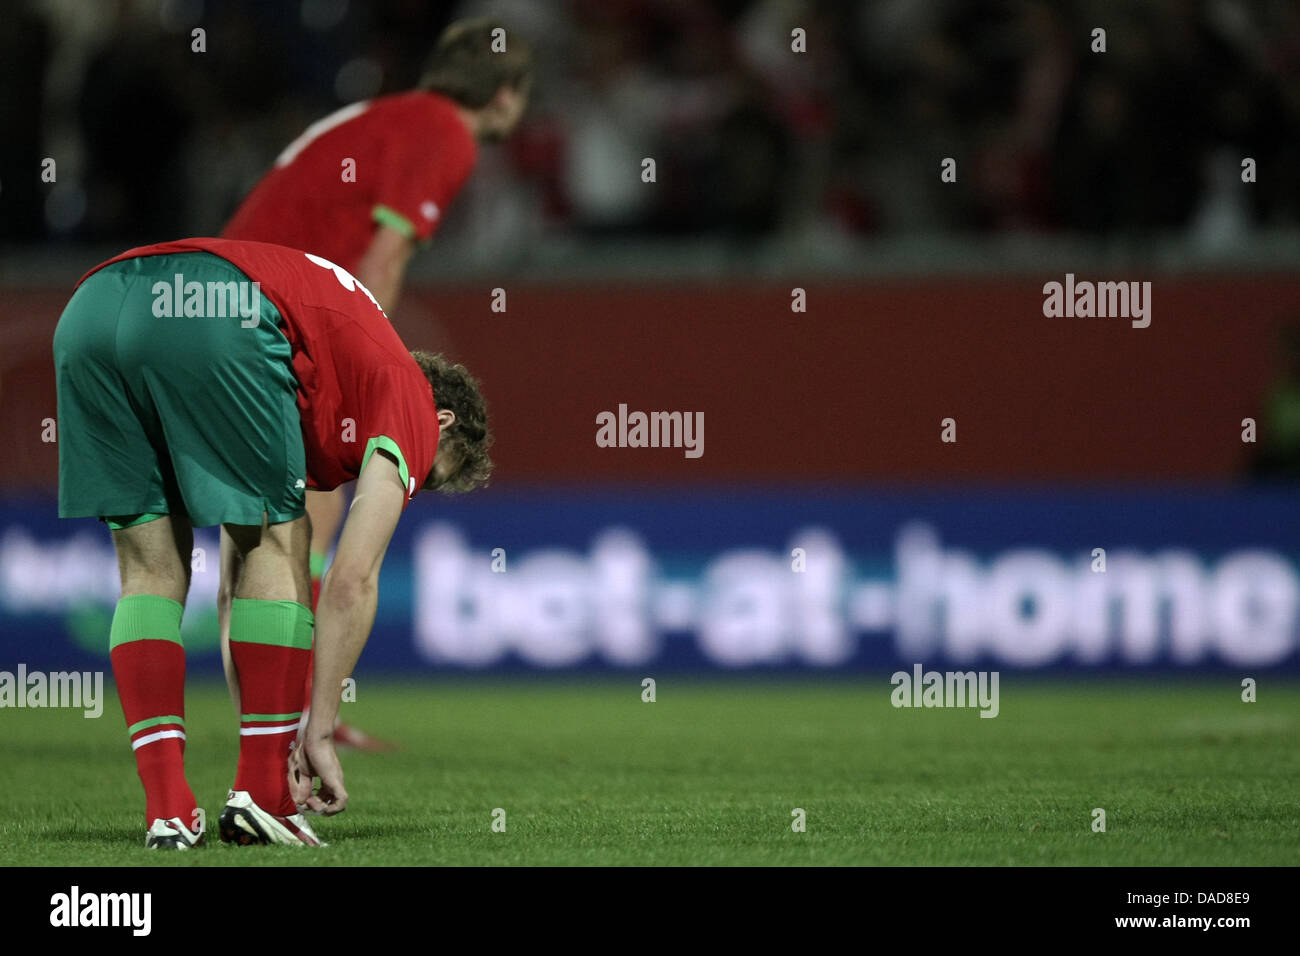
(221, 90, 478, 271)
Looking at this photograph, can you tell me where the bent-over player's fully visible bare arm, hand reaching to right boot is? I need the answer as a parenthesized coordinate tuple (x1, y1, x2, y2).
(289, 449, 407, 814)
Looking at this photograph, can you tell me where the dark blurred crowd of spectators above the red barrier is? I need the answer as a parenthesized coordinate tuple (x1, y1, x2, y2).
(0, 0, 1300, 255)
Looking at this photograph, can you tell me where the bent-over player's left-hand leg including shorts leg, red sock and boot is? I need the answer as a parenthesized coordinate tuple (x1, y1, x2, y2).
(53, 267, 203, 848)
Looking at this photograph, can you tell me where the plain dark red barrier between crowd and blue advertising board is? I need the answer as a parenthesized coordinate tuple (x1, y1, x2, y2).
(0, 276, 1300, 490)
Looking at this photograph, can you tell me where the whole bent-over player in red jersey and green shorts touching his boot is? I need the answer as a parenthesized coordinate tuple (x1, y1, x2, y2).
(53, 239, 491, 848)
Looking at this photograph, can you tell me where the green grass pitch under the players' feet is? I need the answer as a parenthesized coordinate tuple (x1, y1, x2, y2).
(0, 675, 1300, 866)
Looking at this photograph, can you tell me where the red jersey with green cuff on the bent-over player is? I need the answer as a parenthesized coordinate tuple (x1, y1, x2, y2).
(78, 239, 439, 503)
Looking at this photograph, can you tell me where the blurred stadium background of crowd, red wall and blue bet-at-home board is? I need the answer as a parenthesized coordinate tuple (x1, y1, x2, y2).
(0, 0, 1300, 695)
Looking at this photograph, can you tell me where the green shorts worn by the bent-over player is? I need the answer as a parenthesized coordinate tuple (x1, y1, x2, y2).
(55, 252, 307, 527)
